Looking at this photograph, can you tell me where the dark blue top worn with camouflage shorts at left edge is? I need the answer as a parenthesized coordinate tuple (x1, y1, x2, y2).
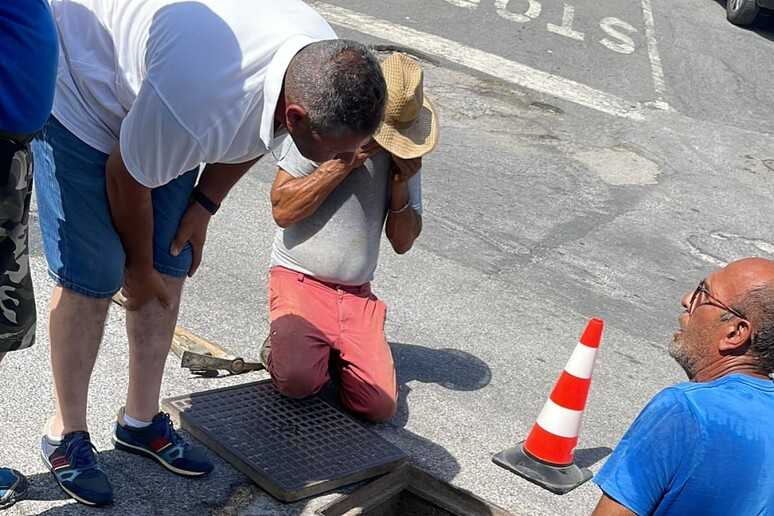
(0, 0, 59, 135)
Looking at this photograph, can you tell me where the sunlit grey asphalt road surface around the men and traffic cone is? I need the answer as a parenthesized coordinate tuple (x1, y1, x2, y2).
(0, 0, 774, 516)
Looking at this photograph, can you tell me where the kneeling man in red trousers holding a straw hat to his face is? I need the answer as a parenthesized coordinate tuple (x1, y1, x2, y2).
(261, 54, 438, 421)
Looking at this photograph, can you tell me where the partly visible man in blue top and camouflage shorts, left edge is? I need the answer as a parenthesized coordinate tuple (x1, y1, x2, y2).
(0, 0, 59, 509)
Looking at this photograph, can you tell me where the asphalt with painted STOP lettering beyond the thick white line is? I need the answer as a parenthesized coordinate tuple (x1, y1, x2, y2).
(318, 0, 774, 132)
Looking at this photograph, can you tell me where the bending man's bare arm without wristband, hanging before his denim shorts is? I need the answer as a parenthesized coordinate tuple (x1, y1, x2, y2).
(105, 147, 169, 310)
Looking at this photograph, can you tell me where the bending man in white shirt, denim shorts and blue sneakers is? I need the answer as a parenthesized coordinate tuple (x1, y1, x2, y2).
(35, 0, 385, 505)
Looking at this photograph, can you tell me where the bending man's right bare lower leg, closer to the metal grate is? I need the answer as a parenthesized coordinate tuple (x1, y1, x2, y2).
(126, 276, 185, 421)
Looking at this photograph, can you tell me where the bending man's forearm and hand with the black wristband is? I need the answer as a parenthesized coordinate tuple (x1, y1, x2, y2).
(170, 159, 258, 277)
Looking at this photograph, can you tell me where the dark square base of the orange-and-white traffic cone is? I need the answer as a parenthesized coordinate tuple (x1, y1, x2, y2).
(492, 441, 593, 494)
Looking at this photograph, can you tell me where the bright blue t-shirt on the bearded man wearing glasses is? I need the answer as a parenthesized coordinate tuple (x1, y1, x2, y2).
(595, 374, 774, 516)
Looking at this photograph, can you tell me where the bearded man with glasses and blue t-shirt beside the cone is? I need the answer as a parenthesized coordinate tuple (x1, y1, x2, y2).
(594, 258, 774, 516)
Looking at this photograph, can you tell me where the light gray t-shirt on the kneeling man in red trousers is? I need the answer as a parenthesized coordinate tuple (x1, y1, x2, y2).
(271, 136, 422, 285)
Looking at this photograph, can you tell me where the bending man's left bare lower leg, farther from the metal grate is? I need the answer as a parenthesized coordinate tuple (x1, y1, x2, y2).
(48, 286, 110, 436)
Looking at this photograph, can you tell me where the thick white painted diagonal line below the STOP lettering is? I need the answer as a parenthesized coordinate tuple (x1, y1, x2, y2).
(311, 2, 645, 120)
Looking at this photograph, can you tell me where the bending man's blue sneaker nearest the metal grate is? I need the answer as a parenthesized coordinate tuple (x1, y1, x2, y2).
(113, 412, 214, 477)
